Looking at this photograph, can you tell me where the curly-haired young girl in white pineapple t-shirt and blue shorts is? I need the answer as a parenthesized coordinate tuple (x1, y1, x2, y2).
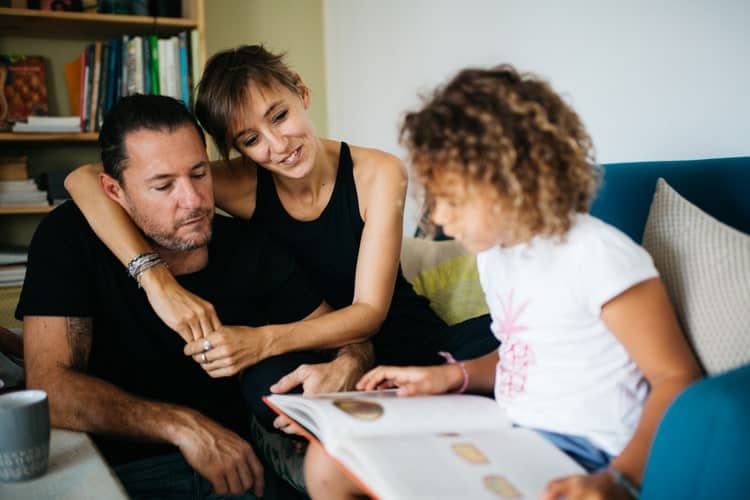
(306, 66, 700, 499)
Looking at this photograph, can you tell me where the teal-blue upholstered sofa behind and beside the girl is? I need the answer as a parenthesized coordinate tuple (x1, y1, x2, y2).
(591, 157, 750, 500)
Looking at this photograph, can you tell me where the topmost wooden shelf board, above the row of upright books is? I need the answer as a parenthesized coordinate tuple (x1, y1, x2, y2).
(0, 7, 198, 40)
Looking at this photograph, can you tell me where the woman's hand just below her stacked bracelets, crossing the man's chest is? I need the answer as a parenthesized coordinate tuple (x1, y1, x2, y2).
(141, 266, 221, 342)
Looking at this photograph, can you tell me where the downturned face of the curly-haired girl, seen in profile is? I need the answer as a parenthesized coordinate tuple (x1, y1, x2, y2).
(430, 172, 519, 253)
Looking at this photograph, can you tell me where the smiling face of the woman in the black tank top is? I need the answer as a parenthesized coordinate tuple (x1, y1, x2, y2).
(230, 83, 318, 179)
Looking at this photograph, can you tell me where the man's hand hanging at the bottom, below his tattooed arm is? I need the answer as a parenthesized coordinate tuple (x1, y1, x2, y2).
(176, 414, 264, 497)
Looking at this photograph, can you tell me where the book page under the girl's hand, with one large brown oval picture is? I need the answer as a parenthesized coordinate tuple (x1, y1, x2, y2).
(266, 390, 511, 450)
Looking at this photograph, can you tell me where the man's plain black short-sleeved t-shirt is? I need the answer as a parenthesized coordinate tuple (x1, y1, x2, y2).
(16, 202, 322, 465)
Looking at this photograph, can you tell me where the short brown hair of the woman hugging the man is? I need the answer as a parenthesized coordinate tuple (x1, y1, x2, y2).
(195, 45, 299, 158)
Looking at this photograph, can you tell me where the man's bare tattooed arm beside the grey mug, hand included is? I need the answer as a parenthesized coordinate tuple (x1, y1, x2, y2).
(24, 316, 263, 495)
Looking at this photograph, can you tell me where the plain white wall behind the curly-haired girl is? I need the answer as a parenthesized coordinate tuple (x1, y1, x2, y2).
(323, 0, 750, 234)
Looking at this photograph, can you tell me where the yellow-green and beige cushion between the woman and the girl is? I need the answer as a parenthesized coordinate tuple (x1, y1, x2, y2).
(401, 238, 488, 325)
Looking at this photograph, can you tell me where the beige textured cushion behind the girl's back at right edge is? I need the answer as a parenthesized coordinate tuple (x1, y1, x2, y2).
(643, 179, 750, 374)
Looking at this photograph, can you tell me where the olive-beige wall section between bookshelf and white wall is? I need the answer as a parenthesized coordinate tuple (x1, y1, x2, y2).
(205, 0, 328, 141)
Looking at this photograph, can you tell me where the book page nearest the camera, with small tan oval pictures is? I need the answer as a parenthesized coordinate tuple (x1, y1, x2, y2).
(336, 427, 584, 499)
